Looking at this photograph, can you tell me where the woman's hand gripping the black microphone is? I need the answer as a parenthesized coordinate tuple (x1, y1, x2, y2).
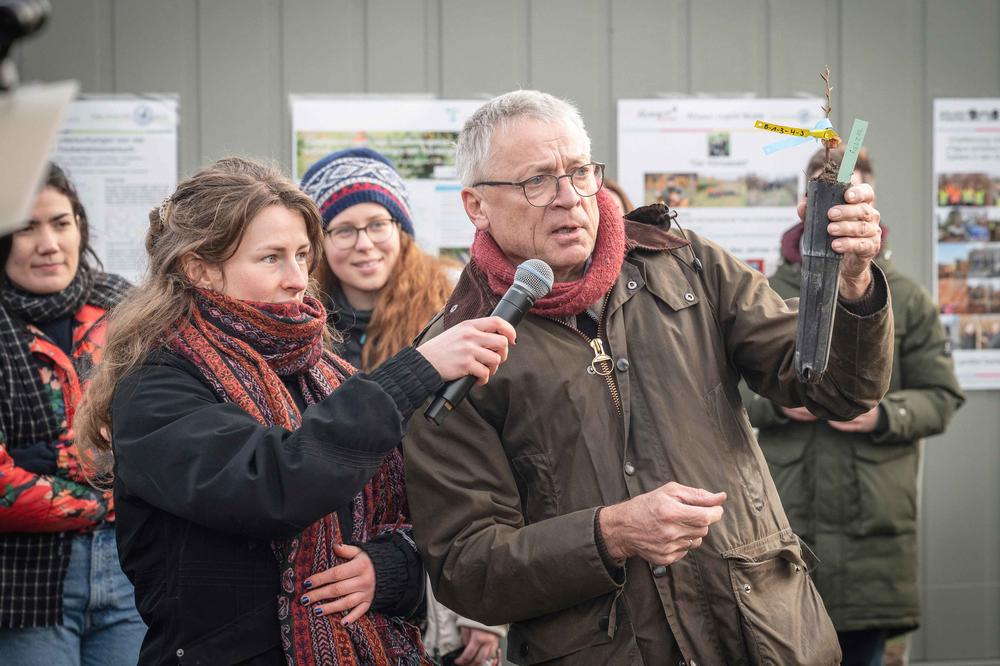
(417, 317, 517, 385)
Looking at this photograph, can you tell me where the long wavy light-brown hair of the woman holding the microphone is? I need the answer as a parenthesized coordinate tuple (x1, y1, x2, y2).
(80, 157, 325, 483)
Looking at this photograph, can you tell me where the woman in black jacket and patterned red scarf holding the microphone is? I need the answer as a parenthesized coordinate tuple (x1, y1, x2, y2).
(80, 158, 514, 666)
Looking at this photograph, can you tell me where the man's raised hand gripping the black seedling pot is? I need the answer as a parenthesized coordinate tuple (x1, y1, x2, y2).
(798, 183, 882, 300)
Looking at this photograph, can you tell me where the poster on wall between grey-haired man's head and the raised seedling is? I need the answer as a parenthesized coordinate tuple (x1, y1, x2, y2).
(617, 98, 823, 275)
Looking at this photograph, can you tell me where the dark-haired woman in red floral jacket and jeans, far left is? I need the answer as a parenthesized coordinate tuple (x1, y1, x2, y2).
(0, 165, 146, 666)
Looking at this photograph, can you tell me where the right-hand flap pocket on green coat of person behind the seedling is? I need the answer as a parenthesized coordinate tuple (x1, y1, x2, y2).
(849, 441, 919, 536)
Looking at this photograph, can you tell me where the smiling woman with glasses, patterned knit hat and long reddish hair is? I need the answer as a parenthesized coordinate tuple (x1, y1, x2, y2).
(302, 148, 505, 666)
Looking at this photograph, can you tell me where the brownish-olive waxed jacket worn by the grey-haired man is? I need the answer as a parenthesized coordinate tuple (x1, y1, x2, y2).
(404, 213, 892, 666)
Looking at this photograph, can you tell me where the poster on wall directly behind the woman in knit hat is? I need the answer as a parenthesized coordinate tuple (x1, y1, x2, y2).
(291, 95, 482, 254)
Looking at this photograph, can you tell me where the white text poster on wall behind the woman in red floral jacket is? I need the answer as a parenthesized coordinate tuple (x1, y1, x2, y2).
(52, 95, 178, 283)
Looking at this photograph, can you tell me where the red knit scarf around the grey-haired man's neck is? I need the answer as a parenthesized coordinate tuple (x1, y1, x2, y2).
(472, 185, 625, 317)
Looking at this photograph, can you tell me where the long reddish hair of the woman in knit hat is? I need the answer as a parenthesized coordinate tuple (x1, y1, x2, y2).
(316, 233, 461, 370)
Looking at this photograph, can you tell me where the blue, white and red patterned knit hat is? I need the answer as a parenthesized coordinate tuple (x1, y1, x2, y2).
(302, 148, 413, 236)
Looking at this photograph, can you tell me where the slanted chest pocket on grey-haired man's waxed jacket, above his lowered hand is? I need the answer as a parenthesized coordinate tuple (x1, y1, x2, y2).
(705, 383, 764, 511)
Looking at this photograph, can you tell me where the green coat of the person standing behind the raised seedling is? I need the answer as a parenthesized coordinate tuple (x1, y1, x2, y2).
(747, 258, 965, 633)
